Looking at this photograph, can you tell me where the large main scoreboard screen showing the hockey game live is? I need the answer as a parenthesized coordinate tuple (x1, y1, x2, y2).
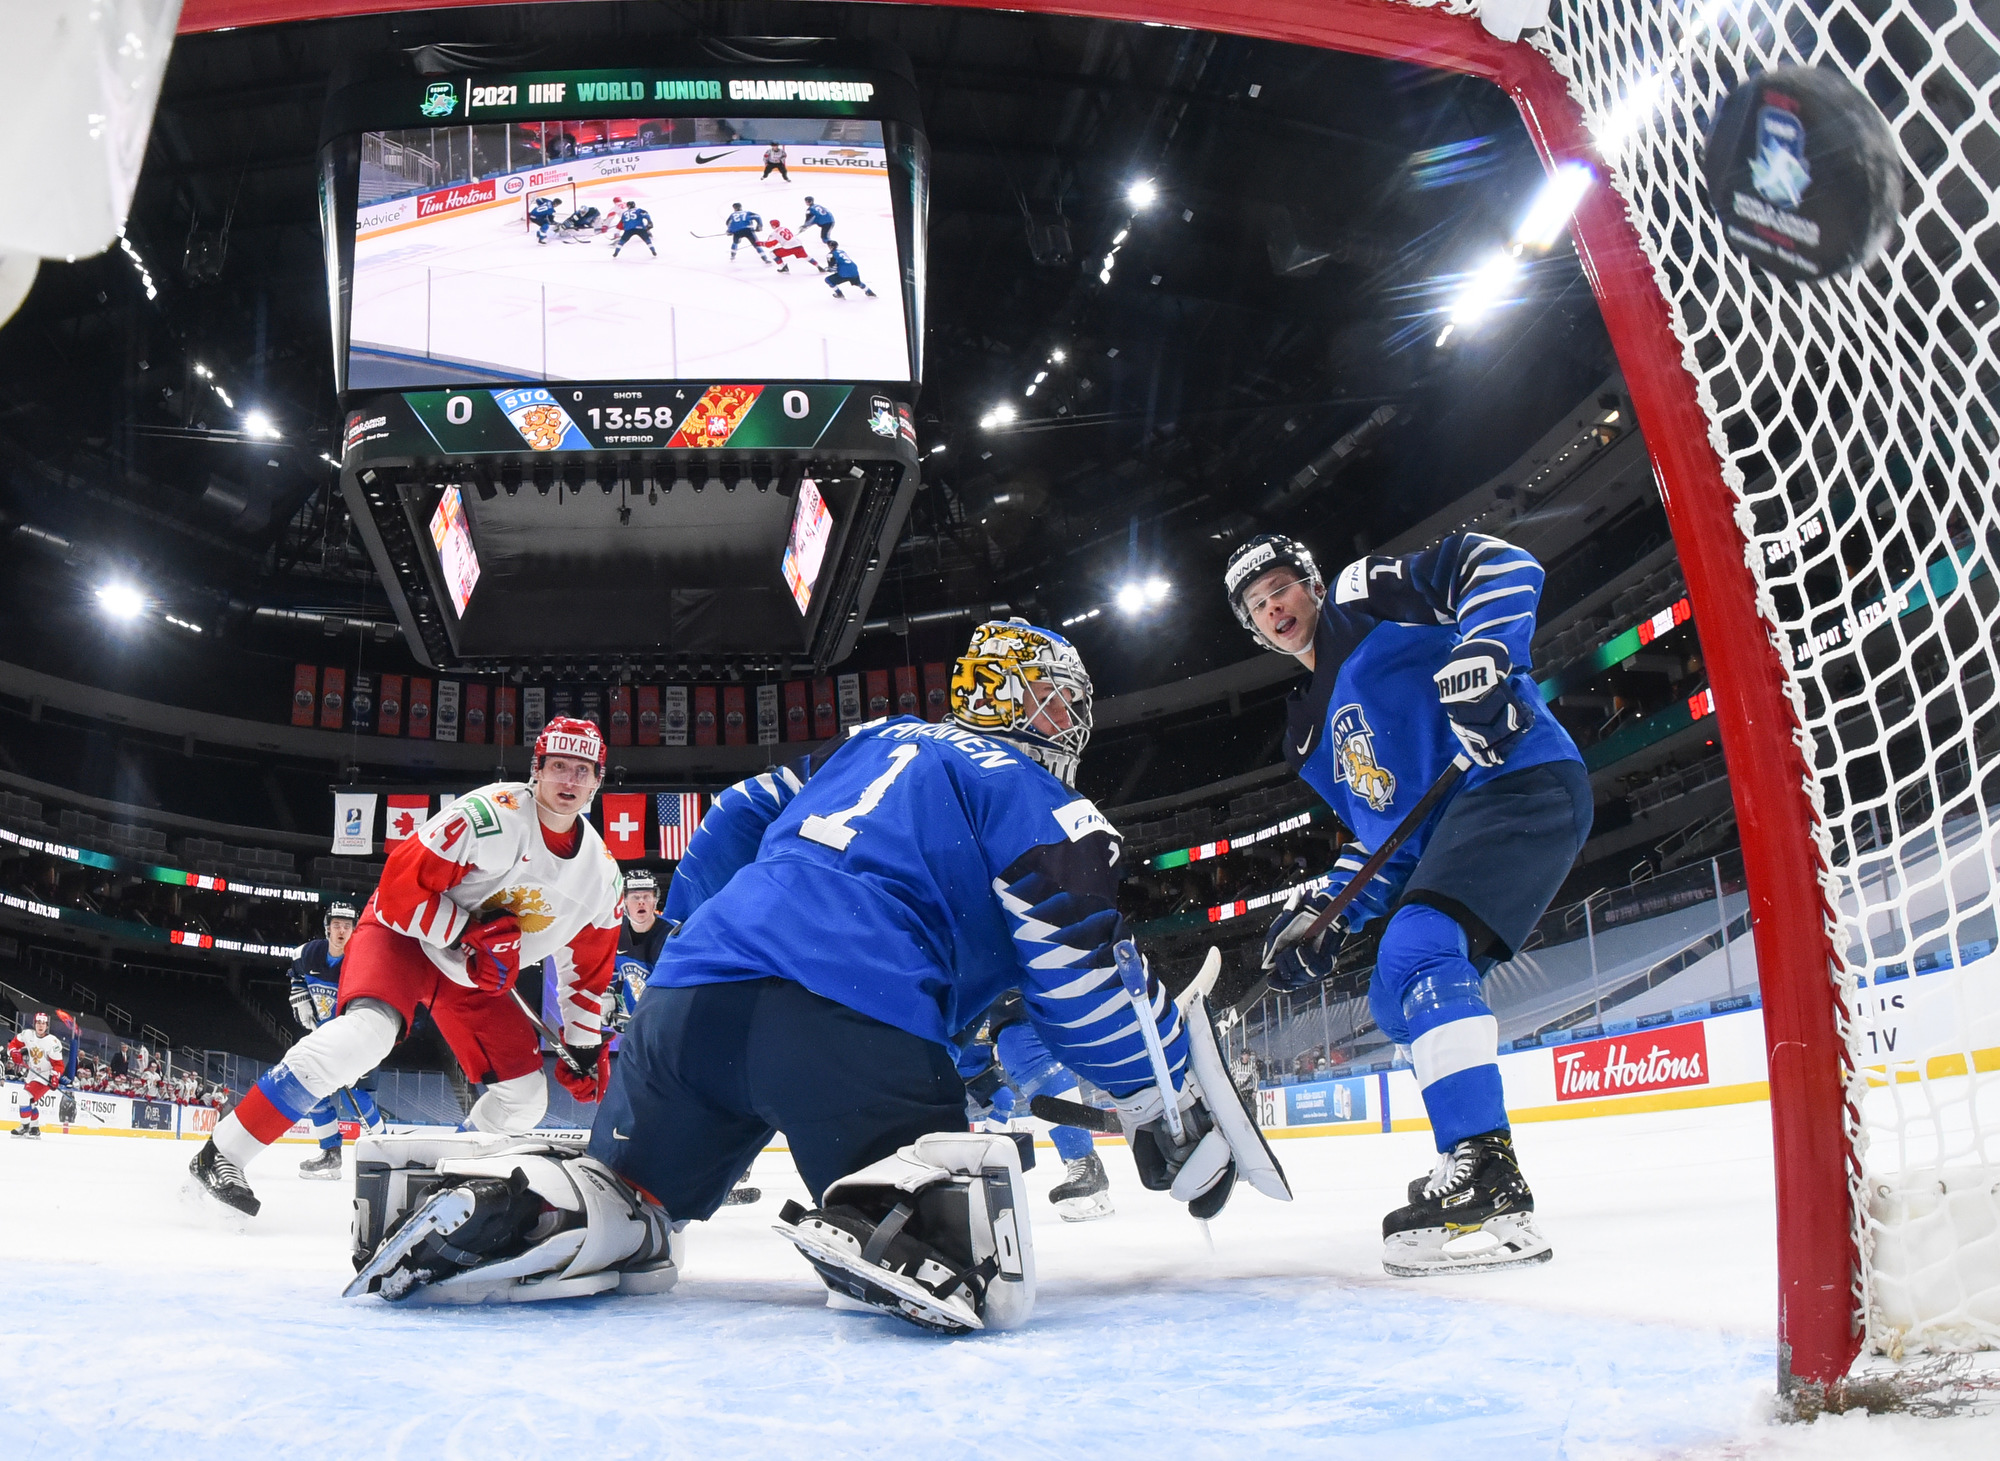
(348, 118, 910, 390)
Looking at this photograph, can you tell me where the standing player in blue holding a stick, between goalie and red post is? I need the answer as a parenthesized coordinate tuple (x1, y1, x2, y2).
(1224, 532, 1592, 1275)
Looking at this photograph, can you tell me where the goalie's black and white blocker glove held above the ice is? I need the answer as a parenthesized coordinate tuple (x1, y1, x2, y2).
(1116, 995, 1292, 1219)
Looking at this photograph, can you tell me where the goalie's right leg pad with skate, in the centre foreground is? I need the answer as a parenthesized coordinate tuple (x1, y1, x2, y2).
(776, 1133, 1034, 1335)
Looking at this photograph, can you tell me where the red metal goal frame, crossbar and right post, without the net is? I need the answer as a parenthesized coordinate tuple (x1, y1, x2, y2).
(180, 0, 1862, 1389)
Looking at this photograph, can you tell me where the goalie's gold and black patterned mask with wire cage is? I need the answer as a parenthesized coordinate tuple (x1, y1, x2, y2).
(952, 618, 1090, 787)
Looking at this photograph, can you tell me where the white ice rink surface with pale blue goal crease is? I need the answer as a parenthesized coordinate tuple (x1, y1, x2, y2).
(0, 1105, 2000, 1461)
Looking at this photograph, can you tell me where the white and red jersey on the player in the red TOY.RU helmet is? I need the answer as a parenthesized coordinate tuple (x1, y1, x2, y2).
(364, 781, 624, 1045)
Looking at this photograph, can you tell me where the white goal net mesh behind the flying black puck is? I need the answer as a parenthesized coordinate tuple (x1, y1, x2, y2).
(1488, 0, 2000, 1355)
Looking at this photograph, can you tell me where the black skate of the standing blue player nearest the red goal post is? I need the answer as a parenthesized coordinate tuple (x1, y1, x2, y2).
(1382, 1131, 1556, 1279)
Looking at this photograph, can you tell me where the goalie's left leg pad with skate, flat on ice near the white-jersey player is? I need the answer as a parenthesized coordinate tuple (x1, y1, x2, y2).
(348, 1133, 684, 1303)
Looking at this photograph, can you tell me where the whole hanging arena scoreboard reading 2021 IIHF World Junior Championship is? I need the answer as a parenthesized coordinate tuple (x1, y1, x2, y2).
(320, 42, 928, 672)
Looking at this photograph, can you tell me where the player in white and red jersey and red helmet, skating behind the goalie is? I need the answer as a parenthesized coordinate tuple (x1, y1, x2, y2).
(188, 716, 622, 1215)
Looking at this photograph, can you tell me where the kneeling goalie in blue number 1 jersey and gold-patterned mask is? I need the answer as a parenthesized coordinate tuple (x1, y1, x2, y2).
(350, 620, 1290, 1333)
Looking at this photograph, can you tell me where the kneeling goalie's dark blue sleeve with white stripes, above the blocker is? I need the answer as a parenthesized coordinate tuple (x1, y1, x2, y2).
(994, 833, 1188, 1097)
